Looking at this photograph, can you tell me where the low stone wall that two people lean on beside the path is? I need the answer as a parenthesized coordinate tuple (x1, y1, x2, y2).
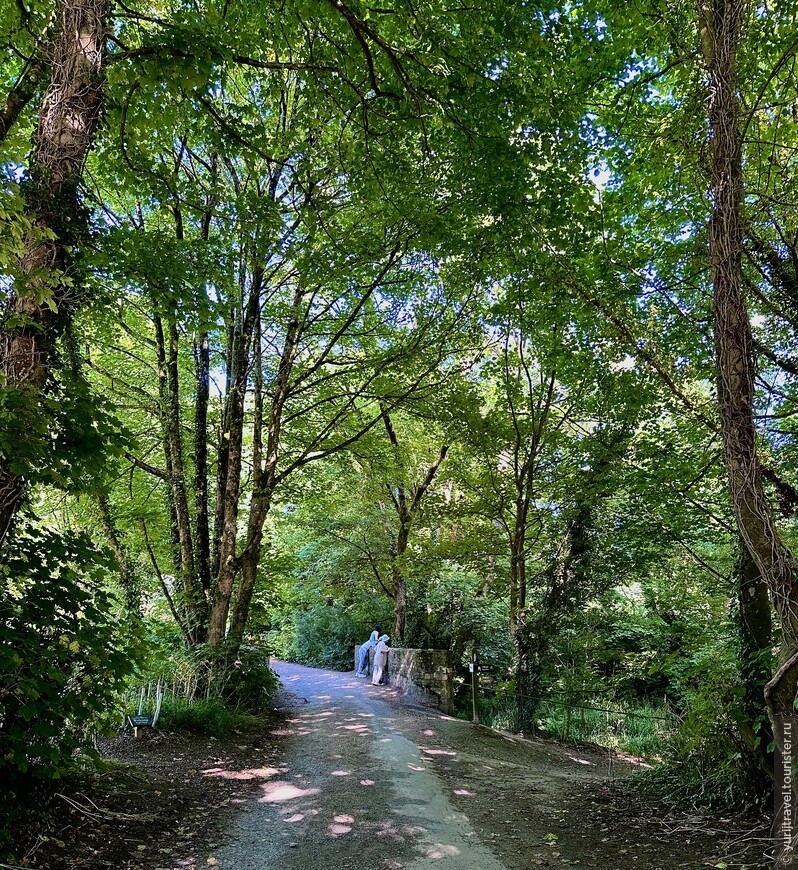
(355, 647, 454, 715)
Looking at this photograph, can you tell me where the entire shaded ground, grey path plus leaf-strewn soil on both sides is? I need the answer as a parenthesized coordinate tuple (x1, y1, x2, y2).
(0, 663, 770, 870)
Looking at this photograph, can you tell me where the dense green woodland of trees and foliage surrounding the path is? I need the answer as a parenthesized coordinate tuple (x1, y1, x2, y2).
(0, 0, 798, 824)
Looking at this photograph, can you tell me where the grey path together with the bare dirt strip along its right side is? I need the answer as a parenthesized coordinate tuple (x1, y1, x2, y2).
(206, 663, 763, 870)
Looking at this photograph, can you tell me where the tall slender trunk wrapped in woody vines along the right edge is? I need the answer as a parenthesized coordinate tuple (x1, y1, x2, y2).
(699, 0, 798, 747)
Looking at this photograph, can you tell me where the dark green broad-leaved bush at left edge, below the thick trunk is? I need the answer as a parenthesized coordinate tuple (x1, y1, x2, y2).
(0, 528, 140, 783)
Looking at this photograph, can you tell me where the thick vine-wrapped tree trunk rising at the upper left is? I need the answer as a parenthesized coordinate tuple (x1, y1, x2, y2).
(0, 0, 108, 544)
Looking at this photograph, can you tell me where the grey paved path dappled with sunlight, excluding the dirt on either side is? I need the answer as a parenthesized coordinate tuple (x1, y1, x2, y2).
(203, 664, 516, 870)
